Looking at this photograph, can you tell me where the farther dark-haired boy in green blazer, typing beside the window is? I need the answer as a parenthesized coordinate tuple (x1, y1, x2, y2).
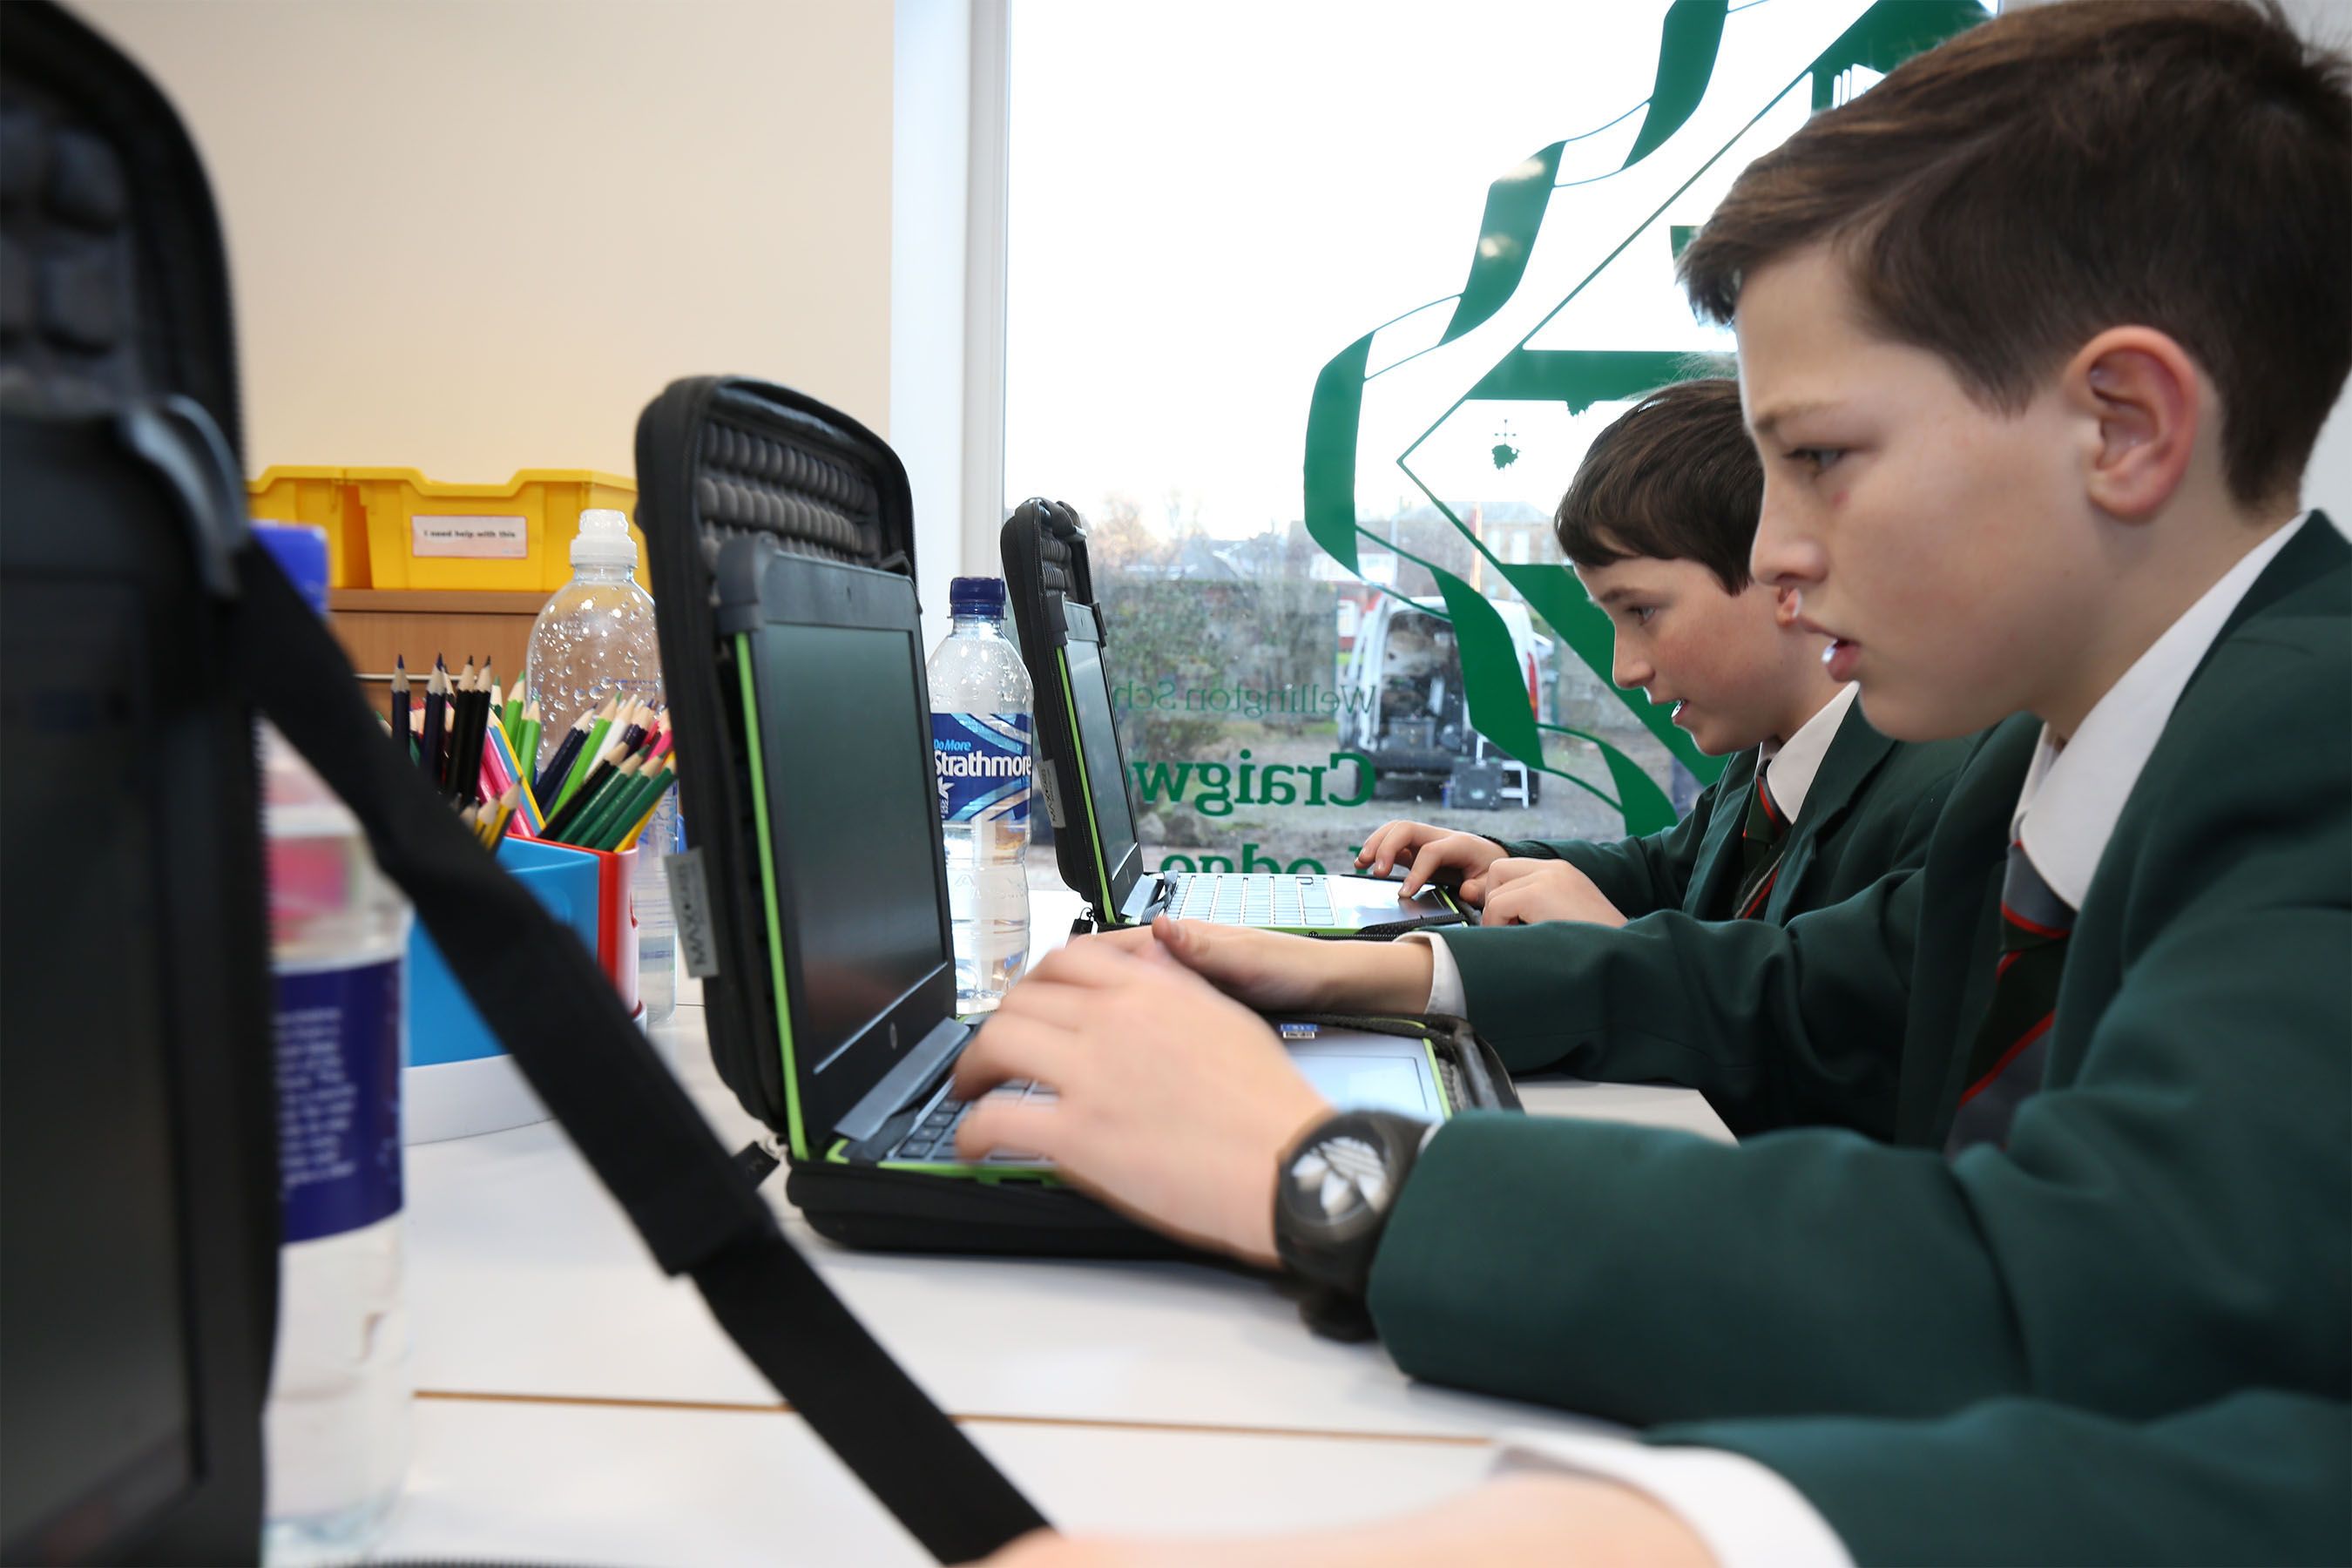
(1357, 376, 1966, 926)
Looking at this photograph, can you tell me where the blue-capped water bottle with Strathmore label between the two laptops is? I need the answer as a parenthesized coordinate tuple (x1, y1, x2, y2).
(929, 576, 1035, 1013)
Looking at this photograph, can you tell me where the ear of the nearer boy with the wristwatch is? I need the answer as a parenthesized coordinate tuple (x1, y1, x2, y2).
(2060, 327, 2218, 522)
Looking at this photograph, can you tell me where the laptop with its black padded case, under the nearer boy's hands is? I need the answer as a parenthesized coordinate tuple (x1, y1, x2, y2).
(638, 381, 1515, 1255)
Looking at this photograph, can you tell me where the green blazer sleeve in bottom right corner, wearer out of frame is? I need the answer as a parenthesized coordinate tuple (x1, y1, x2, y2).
(1649, 1389, 2352, 1565)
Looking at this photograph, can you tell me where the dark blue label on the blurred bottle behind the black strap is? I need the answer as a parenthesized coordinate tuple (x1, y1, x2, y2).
(278, 956, 400, 1241)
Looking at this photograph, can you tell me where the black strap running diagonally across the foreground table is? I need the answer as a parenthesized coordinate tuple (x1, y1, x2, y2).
(231, 543, 1044, 1564)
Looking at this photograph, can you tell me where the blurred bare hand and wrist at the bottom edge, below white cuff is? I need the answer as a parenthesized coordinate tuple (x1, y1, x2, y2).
(964, 1471, 1714, 1568)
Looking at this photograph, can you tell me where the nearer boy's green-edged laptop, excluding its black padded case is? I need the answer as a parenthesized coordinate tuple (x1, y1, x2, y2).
(720, 552, 1484, 1180)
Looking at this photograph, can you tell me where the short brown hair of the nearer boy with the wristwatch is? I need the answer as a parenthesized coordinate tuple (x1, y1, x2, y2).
(1682, 0, 2352, 505)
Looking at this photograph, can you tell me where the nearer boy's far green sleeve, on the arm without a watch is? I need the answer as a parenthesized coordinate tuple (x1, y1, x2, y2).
(1444, 870, 1919, 1138)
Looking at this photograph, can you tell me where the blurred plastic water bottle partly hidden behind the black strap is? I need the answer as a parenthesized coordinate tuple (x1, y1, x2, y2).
(256, 529, 412, 1564)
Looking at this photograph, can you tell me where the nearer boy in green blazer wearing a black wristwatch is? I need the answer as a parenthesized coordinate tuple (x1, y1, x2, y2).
(957, 0, 2352, 1560)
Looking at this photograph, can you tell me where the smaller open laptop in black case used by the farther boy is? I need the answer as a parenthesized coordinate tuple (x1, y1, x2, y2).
(1002, 501, 1470, 936)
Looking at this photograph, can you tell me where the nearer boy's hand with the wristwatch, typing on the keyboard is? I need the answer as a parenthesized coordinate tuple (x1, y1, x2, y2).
(955, 938, 1331, 1267)
